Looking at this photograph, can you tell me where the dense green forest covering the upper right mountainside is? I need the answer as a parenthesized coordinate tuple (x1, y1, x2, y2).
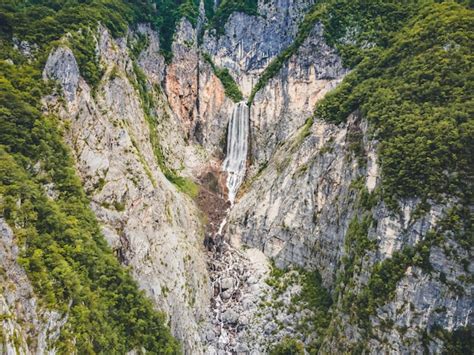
(316, 2, 474, 206)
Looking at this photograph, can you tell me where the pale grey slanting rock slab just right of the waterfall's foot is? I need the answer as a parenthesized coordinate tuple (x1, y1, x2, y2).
(228, 114, 359, 285)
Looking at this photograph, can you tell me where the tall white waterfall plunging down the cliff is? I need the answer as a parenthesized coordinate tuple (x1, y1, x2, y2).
(223, 101, 249, 204)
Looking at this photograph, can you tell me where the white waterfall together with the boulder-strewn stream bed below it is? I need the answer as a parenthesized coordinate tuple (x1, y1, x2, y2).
(204, 102, 255, 355)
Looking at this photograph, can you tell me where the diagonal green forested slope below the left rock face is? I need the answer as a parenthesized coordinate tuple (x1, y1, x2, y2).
(0, 150, 177, 353)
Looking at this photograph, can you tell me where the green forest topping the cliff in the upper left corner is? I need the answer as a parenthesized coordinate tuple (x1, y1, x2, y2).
(0, 0, 155, 97)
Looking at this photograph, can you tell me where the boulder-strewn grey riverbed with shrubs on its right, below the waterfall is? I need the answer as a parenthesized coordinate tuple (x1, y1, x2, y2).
(202, 229, 322, 355)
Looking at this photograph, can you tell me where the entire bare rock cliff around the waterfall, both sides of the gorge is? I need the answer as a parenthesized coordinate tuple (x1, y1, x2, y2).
(0, 0, 473, 354)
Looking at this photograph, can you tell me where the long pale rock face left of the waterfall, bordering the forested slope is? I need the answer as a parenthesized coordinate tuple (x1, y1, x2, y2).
(45, 28, 209, 353)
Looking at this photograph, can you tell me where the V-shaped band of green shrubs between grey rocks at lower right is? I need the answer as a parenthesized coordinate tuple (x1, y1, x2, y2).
(336, 203, 472, 337)
